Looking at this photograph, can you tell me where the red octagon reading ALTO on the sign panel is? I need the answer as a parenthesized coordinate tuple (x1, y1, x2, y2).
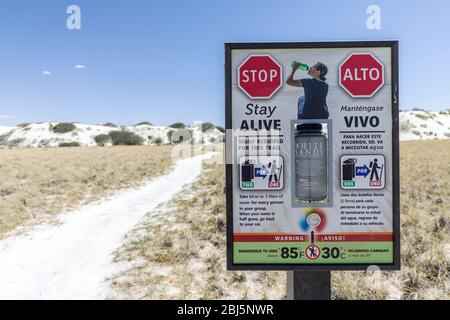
(339, 53, 384, 98)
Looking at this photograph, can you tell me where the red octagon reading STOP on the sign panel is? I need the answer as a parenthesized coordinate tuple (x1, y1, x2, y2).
(238, 55, 282, 99)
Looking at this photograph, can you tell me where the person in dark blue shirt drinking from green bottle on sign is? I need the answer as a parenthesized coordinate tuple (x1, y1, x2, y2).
(286, 61, 329, 119)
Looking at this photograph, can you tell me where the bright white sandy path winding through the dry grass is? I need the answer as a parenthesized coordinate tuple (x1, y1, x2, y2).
(0, 153, 214, 299)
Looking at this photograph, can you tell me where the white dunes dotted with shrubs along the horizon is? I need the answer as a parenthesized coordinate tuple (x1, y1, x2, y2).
(0, 110, 450, 148)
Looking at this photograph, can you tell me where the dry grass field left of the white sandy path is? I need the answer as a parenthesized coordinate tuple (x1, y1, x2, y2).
(0, 146, 172, 238)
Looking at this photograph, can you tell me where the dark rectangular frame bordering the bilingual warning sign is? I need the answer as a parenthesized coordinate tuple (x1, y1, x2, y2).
(225, 40, 400, 271)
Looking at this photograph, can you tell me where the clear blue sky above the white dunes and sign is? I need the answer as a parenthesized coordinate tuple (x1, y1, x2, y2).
(0, 0, 450, 125)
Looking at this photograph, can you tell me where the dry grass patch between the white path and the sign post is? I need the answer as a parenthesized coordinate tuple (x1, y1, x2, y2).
(111, 155, 285, 299)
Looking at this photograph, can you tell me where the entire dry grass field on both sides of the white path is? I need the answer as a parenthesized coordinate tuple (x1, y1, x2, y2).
(0, 140, 450, 299)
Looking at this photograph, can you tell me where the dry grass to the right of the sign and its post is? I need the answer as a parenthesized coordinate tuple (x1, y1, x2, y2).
(333, 140, 450, 299)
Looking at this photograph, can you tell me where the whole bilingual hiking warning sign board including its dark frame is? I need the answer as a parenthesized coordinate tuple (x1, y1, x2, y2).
(225, 41, 400, 270)
